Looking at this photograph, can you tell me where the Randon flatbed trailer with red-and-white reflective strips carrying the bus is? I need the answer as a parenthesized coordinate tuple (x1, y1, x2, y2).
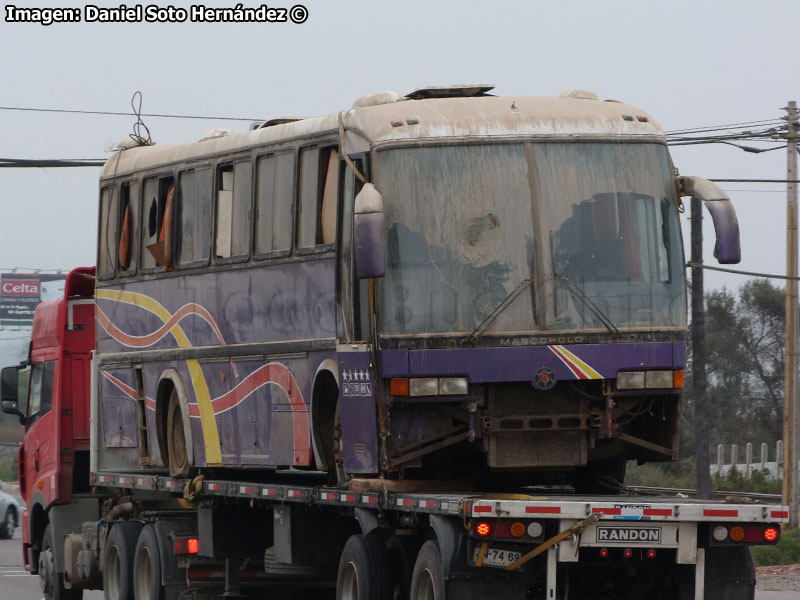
(79, 471, 788, 600)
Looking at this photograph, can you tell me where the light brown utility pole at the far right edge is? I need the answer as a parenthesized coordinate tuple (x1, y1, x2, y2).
(783, 101, 800, 529)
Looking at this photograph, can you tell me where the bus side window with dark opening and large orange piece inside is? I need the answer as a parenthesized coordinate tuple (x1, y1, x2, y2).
(142, 176, 175, 269)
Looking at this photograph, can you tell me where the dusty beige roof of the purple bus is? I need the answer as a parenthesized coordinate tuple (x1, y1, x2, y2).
(101, 96, 663, 178)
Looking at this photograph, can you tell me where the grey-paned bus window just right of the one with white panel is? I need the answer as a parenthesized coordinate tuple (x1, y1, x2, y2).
(255, 153, 294, 255)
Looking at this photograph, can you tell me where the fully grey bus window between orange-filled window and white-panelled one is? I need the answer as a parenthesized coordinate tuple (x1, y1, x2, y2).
(175, 167, 213, 266)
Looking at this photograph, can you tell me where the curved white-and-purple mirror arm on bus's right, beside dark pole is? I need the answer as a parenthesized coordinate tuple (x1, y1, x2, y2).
(678, 177, 742, 265)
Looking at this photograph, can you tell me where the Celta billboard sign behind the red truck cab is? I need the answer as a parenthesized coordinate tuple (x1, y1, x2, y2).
(0, 273, 67, 327)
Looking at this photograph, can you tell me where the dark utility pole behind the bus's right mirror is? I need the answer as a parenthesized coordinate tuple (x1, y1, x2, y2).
(691, 198, 711, 499)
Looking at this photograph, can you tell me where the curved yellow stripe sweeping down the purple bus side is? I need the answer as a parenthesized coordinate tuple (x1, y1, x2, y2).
(95, 290, 222, 465)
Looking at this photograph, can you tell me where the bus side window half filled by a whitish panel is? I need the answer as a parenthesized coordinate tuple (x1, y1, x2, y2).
(214, 162, 253, 258)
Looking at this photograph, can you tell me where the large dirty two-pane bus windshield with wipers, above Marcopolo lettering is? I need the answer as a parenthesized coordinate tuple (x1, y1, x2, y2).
(377, 142, 686, 334)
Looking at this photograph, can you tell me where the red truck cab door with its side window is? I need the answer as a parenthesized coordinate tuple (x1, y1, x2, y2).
(25, 360, 59, 506)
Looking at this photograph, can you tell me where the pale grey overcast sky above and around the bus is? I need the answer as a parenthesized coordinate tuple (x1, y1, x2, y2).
(0, 0, 800, 364)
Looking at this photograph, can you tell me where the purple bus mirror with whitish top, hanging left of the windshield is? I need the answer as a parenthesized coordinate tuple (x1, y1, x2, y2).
(353, 183, 386, 279)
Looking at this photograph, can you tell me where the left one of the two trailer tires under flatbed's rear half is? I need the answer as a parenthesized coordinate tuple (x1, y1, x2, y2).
(336, 535, 391, 600)
